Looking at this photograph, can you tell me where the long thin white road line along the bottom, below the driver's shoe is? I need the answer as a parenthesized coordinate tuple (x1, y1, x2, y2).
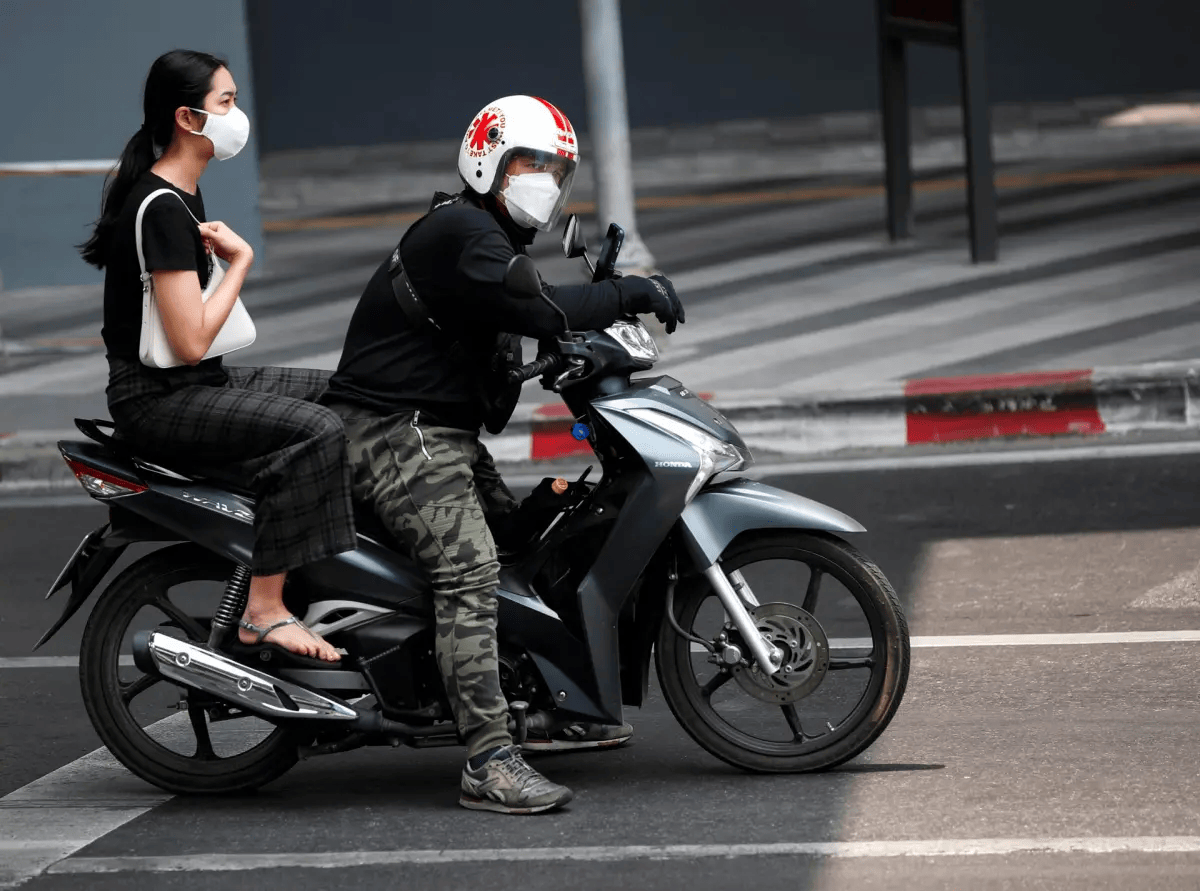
(47, 836, 1200, 875)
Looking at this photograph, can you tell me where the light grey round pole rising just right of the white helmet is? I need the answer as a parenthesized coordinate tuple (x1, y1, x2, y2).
(580, 0, 654, 271)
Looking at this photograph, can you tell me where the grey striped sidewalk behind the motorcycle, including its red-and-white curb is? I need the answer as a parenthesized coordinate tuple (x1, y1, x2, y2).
(0, 96, 1200, 491)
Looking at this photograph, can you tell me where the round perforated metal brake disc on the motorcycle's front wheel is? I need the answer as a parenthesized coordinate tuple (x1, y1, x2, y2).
(732, 603, 829, 705)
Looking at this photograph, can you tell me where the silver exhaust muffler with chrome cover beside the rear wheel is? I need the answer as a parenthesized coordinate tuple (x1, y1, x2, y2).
(133, 632, 359, 720)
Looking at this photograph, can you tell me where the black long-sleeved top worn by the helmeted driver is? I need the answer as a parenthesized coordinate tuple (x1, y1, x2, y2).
(322, 193, 620, 430)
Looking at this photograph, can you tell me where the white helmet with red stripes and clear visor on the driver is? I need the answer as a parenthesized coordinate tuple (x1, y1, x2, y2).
(458, 96, 580, 232)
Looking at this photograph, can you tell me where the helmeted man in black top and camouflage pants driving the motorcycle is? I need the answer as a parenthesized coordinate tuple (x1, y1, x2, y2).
(323, 96, 684, 814)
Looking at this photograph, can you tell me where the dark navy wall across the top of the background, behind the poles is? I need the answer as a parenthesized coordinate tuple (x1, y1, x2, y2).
(247, 0, 1200, 151)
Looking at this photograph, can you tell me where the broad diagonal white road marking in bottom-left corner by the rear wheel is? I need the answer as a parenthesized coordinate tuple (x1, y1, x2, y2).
(0, 744, 175, 889)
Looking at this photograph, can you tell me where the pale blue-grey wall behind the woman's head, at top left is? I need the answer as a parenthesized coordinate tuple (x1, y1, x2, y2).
(0, 0, 262, 288)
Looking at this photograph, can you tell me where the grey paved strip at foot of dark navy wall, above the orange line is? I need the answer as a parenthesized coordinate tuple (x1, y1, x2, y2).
(259, 92, 1200, 223)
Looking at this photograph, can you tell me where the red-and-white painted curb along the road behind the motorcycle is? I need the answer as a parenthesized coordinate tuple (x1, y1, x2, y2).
(0, 359, 1200, 492)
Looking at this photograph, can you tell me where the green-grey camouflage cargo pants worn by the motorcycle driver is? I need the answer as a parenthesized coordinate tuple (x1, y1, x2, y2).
(335, 407, 516, 757)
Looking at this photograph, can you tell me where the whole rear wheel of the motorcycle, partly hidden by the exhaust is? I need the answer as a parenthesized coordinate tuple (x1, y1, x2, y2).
(79, 544, 299, 795)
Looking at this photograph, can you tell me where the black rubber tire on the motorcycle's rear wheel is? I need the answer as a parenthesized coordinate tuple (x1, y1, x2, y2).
(79, 544, 299, 795)
